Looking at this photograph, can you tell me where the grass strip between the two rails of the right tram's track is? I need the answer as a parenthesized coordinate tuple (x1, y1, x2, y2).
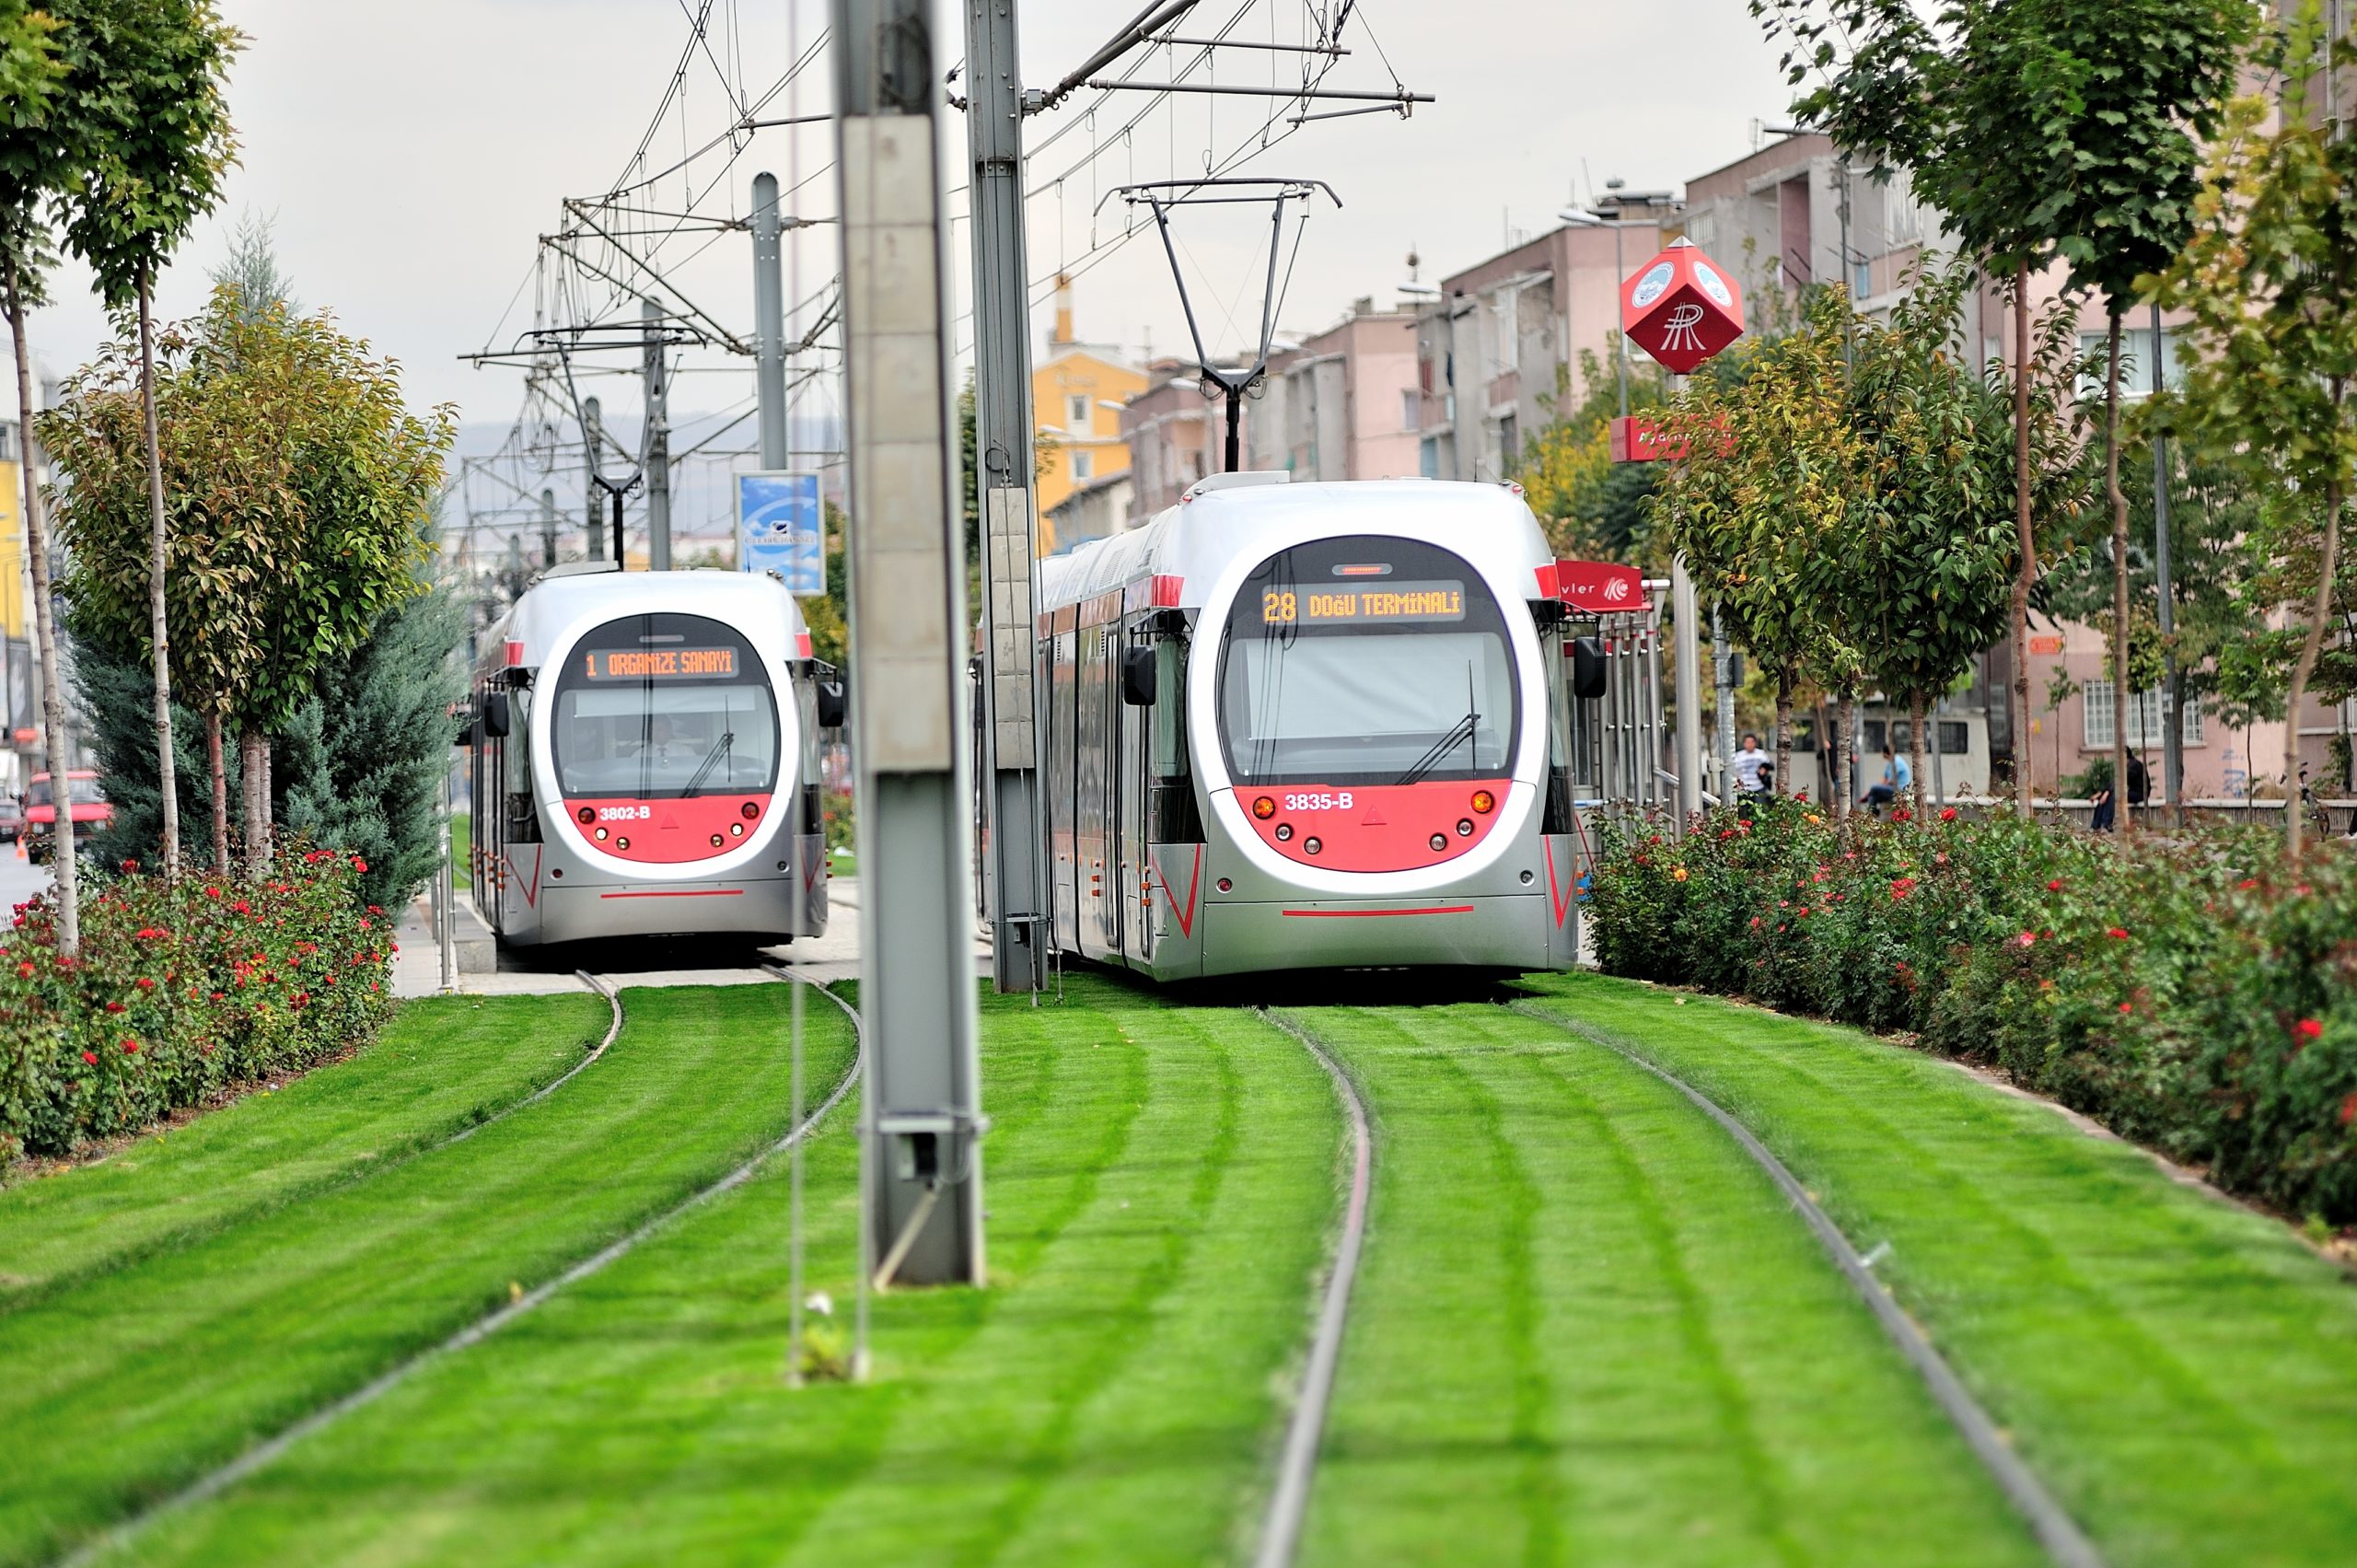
(1292, 1005, 2041, 1568)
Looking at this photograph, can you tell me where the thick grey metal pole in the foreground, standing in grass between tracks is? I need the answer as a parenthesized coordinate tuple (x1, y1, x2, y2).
(832, 0, 985, 1285)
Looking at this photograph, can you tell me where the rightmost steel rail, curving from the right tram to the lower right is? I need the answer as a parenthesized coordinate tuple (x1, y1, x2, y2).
(1511, 1002, 2105, 1568)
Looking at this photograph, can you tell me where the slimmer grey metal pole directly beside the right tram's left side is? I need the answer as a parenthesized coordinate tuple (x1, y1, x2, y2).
(967, 0, 1055, 993)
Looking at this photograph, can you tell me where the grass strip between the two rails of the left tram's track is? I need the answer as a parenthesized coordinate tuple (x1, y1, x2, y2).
(0, 985, 849, 1563)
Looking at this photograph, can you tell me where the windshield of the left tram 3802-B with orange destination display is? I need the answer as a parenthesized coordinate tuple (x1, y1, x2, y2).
(549, 615, 778, 799)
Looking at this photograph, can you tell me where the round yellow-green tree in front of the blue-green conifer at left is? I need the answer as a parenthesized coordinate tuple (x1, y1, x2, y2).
(41, 287, 455, 870)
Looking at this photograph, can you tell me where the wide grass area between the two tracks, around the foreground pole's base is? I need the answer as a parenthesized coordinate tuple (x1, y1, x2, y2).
(106, 979, 1341, 1565)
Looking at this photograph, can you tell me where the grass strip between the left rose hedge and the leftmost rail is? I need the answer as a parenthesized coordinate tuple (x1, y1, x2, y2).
(0, 993, 613, 1310)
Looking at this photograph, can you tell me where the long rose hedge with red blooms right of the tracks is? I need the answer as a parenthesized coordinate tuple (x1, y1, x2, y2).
(1588, 802, 2357, 1224)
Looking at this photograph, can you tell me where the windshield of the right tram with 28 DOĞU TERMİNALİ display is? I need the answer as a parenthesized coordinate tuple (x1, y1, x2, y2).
(1219, 538, 1520, 785)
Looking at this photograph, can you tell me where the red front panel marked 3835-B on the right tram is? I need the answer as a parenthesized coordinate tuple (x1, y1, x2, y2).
(1235, 778, 1508, 870)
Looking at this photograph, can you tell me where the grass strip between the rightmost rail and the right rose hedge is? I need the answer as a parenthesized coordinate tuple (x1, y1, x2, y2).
(1535, 974, 2357, 1568)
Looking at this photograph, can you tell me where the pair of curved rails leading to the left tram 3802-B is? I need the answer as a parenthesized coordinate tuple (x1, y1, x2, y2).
(54, 967, 867, 1568)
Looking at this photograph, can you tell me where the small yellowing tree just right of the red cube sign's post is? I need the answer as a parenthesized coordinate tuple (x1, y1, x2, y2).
(1650, 290, 1860, 787)
